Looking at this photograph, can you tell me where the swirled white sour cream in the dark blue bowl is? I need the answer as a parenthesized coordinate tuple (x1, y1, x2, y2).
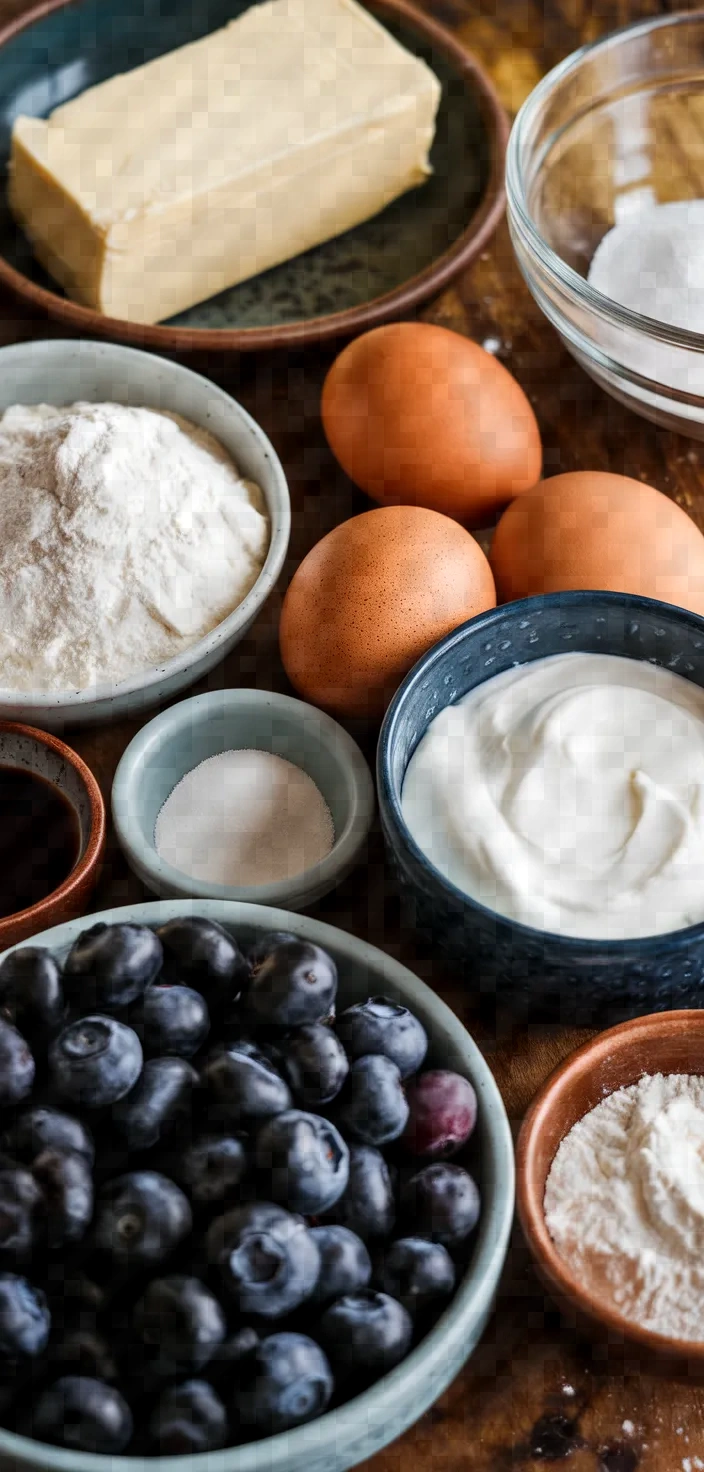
(402, 654, 704, 939)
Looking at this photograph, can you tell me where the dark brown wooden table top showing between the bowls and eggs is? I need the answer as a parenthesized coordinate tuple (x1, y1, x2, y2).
(0, 0, 704, 1472)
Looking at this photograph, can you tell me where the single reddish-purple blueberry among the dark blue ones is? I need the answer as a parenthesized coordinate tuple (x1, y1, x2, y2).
(404, 1069, 477, 1160)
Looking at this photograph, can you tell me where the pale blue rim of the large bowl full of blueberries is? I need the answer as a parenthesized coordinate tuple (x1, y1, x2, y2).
(0, 899, 515, 1472)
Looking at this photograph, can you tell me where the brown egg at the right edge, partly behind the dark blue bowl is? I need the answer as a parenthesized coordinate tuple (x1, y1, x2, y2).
(490, 471, 704, 614)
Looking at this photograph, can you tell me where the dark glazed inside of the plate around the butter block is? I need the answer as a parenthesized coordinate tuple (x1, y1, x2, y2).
(0, 0, 489, 328)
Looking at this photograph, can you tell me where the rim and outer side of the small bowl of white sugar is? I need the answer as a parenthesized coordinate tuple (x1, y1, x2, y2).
(112, 686, 376, 908)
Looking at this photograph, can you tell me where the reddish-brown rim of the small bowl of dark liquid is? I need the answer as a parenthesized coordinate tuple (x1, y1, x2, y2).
(0, 720, 108, 948)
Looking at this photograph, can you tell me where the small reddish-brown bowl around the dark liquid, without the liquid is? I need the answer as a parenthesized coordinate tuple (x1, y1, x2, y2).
(0, 721, 106, 951)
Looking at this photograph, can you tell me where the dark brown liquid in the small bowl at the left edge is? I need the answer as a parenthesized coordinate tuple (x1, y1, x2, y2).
(0, 765, 81, 919)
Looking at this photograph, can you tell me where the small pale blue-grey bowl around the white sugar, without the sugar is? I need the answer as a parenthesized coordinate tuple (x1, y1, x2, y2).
(112, 690, 374, 910)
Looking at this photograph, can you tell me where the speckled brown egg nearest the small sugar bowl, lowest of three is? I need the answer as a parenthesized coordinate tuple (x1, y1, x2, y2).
(280, 506, 496, 717)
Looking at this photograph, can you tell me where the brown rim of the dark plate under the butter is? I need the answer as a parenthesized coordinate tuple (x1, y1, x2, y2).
(0, 0, 510, 352)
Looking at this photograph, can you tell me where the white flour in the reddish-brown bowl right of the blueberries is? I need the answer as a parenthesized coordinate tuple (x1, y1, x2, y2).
(545, 1073, 704, 1340)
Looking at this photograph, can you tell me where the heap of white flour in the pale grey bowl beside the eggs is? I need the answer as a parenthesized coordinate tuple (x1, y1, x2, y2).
(0, 403, 270, 690)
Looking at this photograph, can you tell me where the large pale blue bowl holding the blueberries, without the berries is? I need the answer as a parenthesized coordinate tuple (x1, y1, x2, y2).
(0, 899, 514, 1472)
